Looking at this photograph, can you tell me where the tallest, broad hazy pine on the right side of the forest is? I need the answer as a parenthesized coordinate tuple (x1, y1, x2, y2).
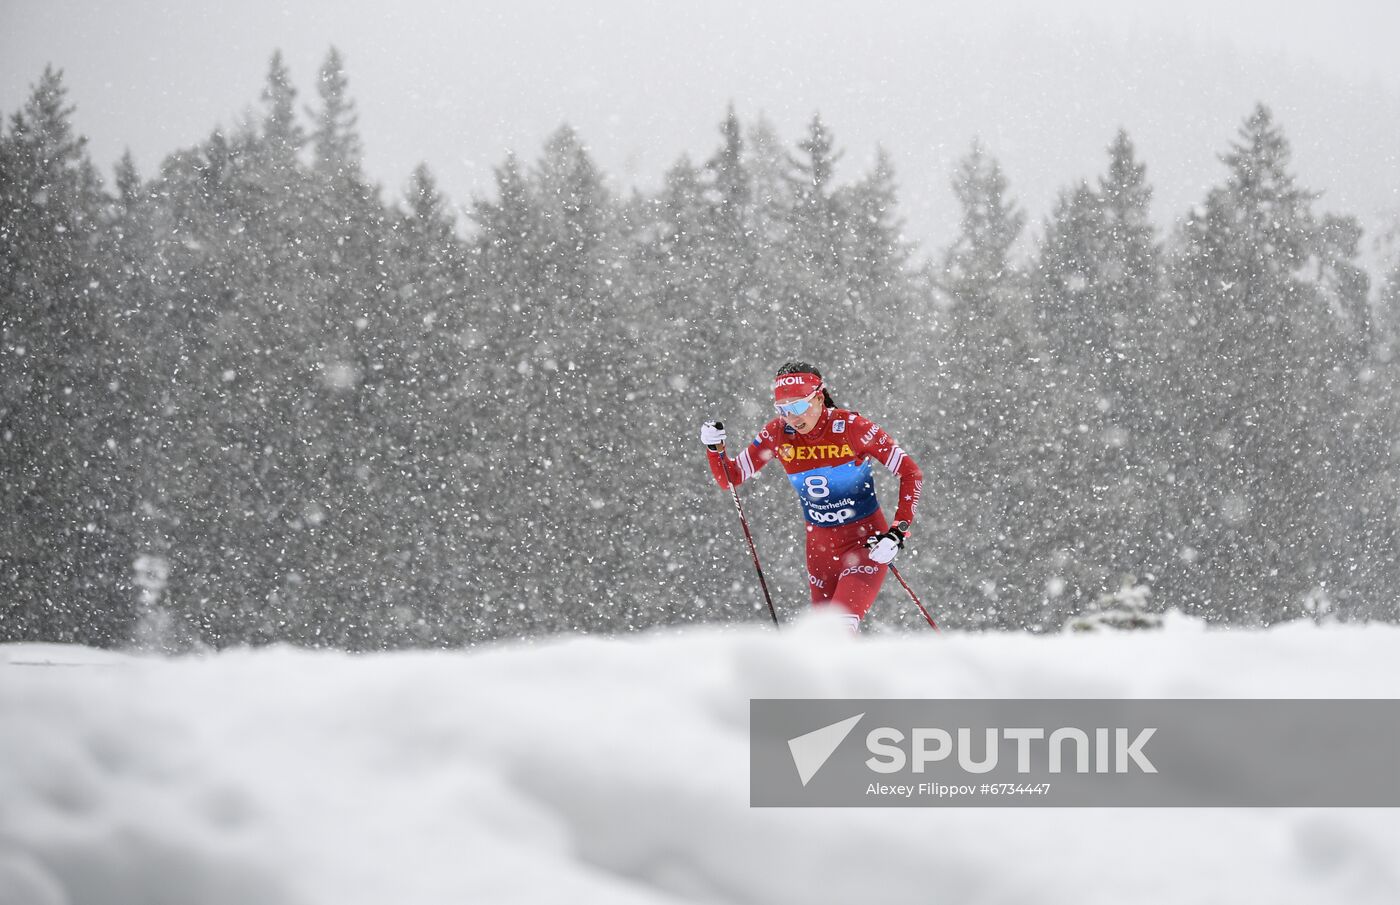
(1173, 105, 1361, 622)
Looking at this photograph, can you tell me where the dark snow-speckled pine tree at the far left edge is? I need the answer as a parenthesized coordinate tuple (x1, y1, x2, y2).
(0, 69, 133, 644)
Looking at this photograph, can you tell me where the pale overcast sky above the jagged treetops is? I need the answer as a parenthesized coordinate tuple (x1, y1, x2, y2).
(8, 0, 1400, 261)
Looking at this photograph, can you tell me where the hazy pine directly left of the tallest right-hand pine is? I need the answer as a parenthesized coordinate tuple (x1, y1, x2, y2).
(1032, 132, 1170, 627)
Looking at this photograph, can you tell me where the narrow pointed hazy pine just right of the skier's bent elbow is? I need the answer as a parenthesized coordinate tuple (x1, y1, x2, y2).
(916, 143, 1049, 625)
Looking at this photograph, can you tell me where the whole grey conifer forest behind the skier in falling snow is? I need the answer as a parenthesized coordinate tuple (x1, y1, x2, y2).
(0, 50, 1400, 650)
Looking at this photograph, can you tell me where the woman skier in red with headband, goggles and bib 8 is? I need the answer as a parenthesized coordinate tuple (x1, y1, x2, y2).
(700, 361, 924, 630)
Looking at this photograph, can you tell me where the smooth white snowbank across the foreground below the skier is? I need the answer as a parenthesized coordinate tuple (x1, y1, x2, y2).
(0, 625, 1400, 905)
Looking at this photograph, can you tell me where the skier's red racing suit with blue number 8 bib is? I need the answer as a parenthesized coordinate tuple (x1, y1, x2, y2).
(708, 409, 924, 618)
